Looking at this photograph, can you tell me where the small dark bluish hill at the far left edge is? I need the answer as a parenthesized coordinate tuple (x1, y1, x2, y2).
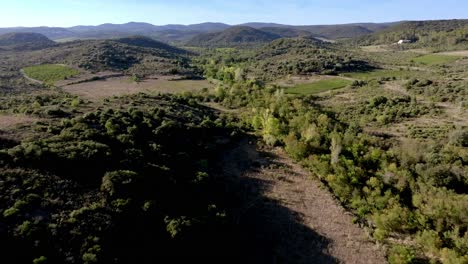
(0, 33, 56, 50)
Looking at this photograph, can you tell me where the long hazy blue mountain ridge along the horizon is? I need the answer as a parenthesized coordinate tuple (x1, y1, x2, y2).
(0, 22, 393, 42)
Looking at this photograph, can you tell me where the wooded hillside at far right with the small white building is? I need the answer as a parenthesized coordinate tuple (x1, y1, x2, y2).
(356, 20, 468, 49)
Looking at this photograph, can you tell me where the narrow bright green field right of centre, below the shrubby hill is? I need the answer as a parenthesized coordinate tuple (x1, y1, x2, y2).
(286, 78, 352, 95)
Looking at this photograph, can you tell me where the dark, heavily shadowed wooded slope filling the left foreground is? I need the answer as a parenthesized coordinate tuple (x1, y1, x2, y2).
(0, 95, 249, 263)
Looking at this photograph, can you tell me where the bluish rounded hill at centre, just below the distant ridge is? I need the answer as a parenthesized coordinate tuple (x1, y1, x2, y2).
(186, 26, 281, 47)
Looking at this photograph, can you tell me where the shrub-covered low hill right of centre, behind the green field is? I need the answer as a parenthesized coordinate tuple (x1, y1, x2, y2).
(202, 38, 371, 82)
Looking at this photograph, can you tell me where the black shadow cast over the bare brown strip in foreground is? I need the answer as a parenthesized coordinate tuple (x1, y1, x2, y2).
(219, 138, 338, 264)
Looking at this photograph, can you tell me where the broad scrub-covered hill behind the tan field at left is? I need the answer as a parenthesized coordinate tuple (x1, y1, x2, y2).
(7, 36, 192, 76)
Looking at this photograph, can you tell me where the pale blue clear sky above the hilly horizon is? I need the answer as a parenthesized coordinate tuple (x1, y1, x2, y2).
(0, 0, 468, 27)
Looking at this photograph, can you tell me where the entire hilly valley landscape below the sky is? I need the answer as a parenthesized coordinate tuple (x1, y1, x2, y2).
(0, 16, 468, 264)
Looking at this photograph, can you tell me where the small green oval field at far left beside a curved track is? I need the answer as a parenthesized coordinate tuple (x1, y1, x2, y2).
(23, 64, 80, 84)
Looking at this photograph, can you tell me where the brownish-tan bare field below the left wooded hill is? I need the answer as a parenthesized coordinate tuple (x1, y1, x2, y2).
(63, 77, 213, 100)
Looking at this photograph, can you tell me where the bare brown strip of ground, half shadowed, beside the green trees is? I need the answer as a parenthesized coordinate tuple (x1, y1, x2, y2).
(223, 137, 386, 264)
